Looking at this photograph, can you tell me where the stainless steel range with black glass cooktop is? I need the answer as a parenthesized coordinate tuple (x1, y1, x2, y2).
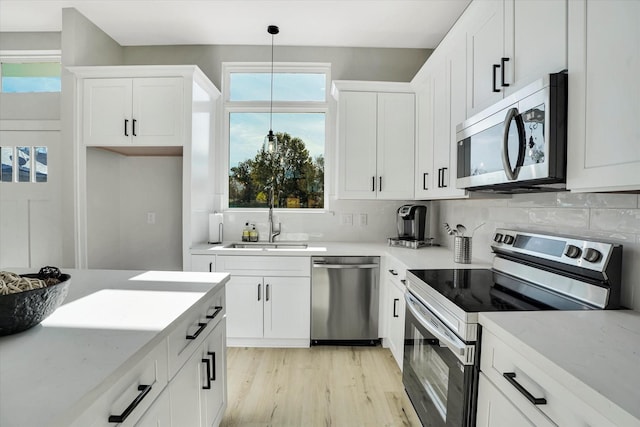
(403, 229, 622, 427)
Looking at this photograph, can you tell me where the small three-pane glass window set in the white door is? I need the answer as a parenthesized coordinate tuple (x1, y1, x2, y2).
(0, 146, 48, 182)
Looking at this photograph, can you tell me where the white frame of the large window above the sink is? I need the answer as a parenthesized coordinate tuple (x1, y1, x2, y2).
(220, 62, 333, 213)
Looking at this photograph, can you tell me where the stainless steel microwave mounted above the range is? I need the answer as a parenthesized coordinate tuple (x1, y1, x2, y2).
(456, 72, 567, 193)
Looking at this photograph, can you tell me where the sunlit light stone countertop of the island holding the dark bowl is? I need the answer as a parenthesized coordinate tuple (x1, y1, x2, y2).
(0, 269, 229, 427)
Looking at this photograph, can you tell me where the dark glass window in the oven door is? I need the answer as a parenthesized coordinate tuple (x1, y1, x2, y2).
(410, 328, 449, 420)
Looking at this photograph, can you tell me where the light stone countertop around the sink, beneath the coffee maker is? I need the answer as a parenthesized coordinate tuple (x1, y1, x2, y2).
(191, 242, 491, 269)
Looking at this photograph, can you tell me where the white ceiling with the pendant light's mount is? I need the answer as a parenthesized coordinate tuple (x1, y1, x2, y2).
(0, 0, 470, 48)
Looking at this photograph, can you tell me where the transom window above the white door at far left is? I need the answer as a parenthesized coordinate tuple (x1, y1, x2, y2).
(0, 52, 61, 93)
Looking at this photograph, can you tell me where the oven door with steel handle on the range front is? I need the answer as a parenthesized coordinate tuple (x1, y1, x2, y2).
(402, 292, 477, 427)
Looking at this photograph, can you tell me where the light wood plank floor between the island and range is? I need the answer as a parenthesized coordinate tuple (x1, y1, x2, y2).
(221, 346, 420, 427)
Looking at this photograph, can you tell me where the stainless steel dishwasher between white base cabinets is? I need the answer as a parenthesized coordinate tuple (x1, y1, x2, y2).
(311, 257, 380, 345)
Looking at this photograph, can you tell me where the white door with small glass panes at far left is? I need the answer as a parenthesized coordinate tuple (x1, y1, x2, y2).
(0, 128, 62, 269)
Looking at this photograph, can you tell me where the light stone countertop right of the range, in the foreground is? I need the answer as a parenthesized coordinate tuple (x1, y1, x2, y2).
(479, 310, 640, 427)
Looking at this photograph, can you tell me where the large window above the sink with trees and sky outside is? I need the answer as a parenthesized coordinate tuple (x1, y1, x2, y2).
(224, 64, 330, 209)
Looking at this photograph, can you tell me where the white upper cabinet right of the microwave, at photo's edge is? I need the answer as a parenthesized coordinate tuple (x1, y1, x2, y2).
(567, 0, 640, 191)
